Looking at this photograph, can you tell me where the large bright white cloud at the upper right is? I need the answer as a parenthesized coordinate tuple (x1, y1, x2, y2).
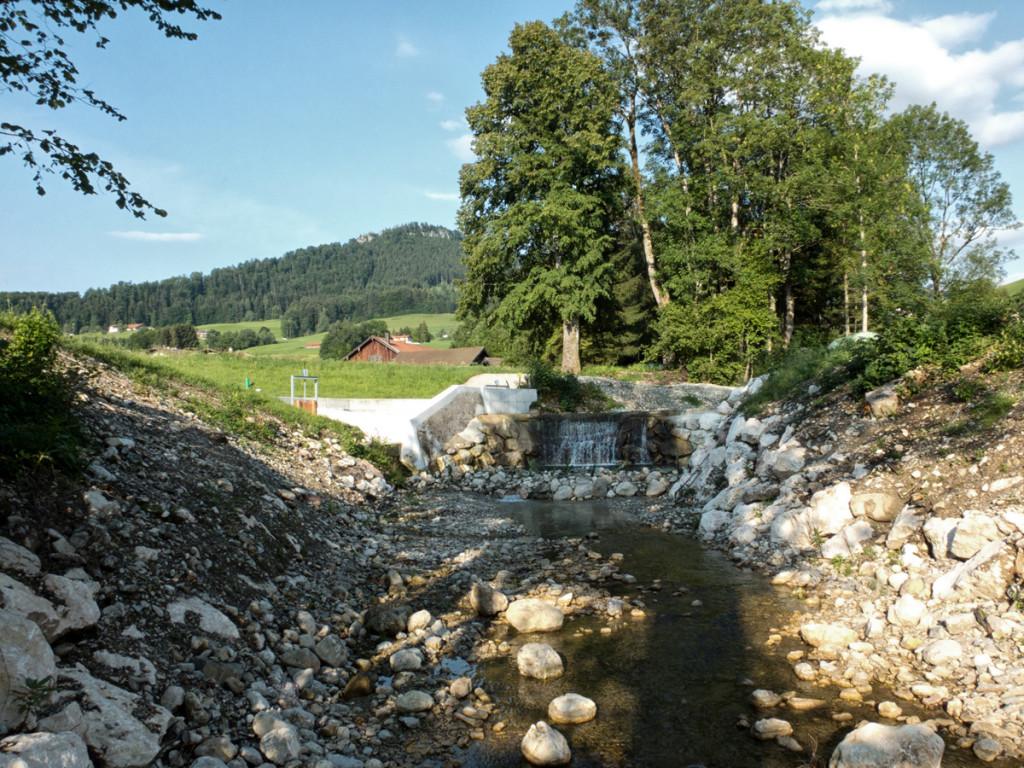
(815, 7, 1024, 148)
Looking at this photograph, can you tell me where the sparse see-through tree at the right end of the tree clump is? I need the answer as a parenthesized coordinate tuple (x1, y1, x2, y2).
(890, 103, 1020, 297)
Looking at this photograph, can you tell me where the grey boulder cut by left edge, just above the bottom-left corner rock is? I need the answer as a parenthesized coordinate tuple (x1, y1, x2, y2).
(0, 609, 57, 732)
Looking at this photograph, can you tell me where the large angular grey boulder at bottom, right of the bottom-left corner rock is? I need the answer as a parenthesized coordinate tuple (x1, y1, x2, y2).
(55, 666, 171, 768)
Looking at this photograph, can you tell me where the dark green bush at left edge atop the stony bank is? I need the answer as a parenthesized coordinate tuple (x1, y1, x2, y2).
(0, 309, 84, 477)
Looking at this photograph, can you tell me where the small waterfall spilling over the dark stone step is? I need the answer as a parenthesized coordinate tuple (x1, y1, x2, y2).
(539, 413, 650, 467)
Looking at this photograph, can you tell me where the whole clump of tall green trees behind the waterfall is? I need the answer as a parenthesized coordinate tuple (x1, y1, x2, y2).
(456, 0, 1019, 382)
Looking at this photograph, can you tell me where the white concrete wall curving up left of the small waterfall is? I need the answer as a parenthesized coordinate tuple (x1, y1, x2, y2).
(280, 374, 537, 471)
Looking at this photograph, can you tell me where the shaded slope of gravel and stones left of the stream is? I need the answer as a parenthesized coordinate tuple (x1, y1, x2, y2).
(0, 360, 634, 768)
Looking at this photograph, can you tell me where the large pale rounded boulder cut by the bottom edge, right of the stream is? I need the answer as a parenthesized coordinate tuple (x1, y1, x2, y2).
(828, 723, 945, 768)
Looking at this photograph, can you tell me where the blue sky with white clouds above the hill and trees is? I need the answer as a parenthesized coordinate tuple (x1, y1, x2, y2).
(0, 0, 1024, 291)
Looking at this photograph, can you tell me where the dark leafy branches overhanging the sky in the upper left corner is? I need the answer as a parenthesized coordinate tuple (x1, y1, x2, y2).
(0, 0, 220, 218)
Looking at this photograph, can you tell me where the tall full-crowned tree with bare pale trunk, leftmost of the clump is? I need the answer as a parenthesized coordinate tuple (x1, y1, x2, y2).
(459, 22, 623, 372)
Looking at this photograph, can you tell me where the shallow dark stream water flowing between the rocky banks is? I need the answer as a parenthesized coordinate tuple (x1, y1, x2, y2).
(467, 502, 981, 768)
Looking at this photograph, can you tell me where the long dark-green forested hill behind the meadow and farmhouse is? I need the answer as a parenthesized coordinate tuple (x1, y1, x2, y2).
(0, 223, 464, 336)
